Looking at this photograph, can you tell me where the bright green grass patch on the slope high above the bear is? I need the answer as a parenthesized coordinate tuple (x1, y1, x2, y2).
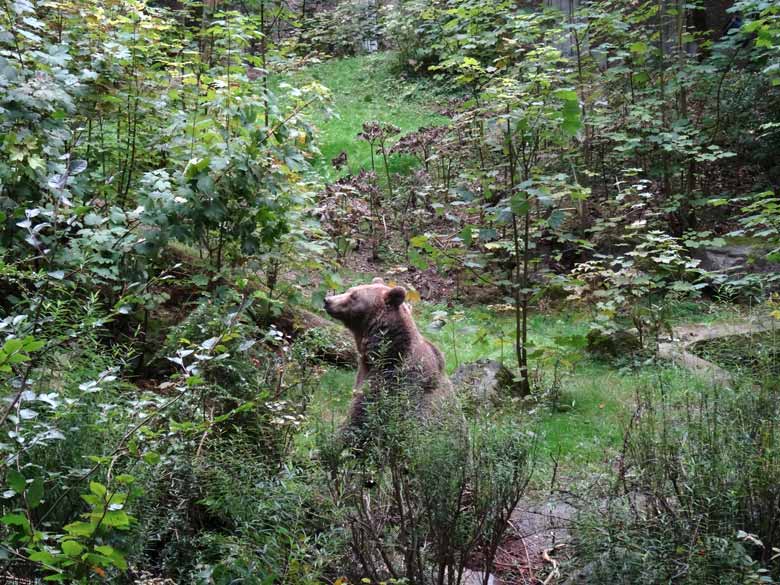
(275, 53, 448, 181)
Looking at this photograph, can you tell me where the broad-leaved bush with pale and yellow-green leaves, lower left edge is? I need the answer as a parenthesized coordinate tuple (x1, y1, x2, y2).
(0, 287, 156, 583)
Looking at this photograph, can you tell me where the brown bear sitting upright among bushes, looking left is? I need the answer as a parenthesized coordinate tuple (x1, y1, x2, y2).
(325, 278, 452, 428)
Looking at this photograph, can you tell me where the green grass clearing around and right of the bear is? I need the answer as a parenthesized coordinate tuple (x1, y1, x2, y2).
(298, 296, 733, 472)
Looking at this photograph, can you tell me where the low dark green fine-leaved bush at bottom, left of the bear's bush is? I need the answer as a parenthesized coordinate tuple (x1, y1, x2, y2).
(129, 441, 340, 585)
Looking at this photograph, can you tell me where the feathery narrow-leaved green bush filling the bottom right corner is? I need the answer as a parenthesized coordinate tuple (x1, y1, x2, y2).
(577, 376, 780, 584)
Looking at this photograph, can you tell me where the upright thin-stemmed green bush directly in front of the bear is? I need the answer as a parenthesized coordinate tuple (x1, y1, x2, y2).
(321, 380, 531, 585)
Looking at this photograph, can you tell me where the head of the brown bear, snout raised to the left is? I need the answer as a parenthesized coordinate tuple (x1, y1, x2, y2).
(325, 278, 409, 333)
